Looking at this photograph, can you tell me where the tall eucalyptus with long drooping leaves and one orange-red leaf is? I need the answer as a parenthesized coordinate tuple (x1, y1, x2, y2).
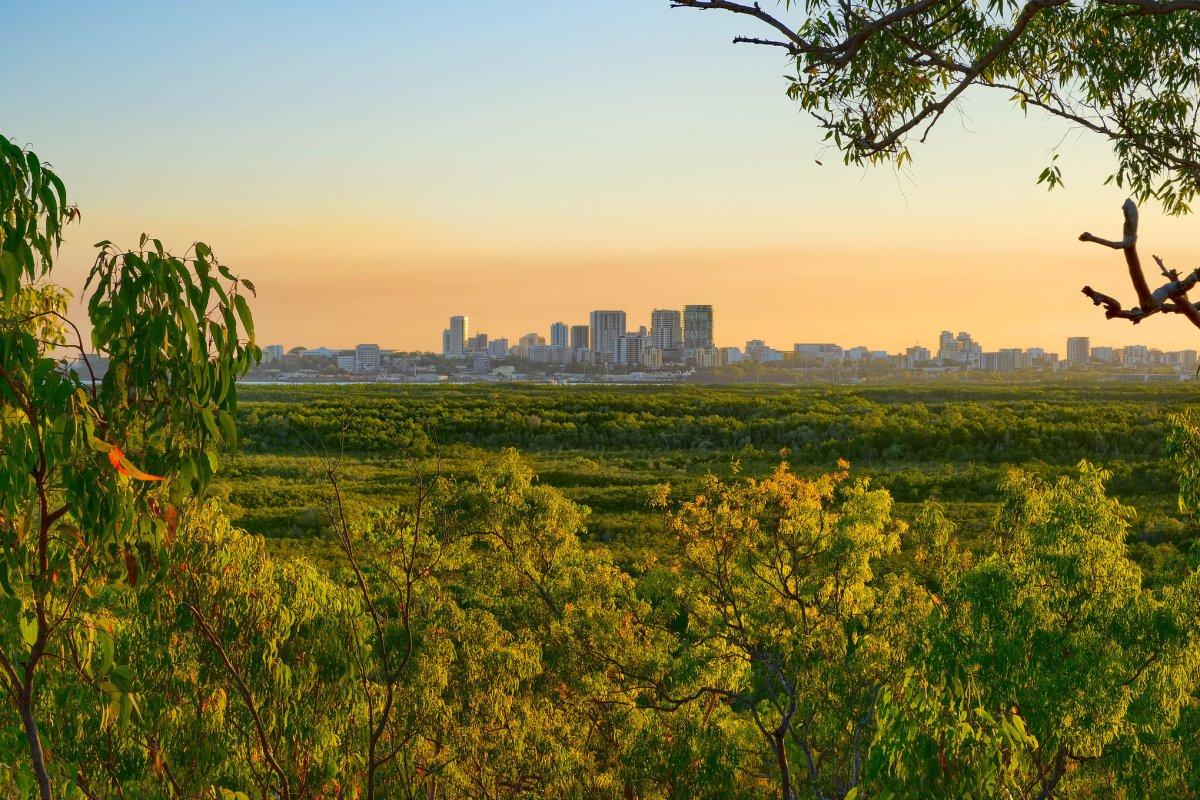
(0, 137, 259, 800)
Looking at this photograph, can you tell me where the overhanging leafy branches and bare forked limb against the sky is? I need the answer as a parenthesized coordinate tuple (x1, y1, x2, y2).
(671, 0, 1200, 327)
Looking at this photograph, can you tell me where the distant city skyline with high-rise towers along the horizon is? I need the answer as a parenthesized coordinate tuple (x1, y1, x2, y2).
(238, 305, 1196, 383)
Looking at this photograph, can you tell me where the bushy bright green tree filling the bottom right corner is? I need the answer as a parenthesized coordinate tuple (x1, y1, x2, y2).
(864, 463, 1200, 800)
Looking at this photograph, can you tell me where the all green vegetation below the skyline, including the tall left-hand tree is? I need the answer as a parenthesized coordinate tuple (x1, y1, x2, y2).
(7, 139, 1200, 800)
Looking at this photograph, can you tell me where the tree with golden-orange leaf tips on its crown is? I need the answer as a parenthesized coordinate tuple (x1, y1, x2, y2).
(659, 465, 929, 800)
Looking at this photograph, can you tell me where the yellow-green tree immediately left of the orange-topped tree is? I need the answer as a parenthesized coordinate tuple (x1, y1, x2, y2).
(432, 451, 647, 798)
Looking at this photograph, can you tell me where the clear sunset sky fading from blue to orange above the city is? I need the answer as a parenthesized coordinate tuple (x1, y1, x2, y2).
(9, 0, 1200, 353)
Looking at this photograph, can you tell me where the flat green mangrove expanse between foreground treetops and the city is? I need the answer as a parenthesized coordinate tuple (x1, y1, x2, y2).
(217, 385, 1194, 576)
